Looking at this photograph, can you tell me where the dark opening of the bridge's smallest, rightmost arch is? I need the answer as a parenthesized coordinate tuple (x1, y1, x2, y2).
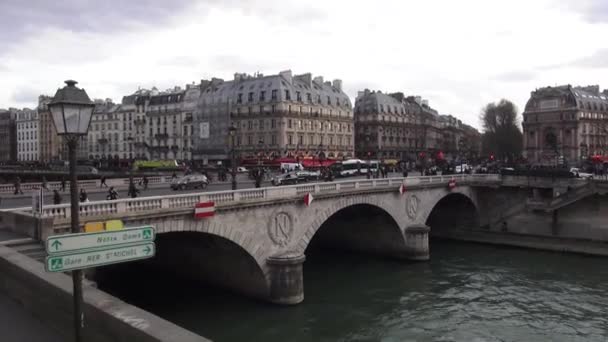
(425, 189, 479, 235)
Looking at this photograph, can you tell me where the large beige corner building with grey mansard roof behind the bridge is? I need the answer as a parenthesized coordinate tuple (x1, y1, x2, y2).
(193, 70, 354, 163)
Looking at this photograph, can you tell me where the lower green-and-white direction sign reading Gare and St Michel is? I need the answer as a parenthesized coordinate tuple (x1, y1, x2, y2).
(45, 242, 156, 272)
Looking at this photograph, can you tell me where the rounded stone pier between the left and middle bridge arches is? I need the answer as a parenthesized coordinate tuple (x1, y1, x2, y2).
(266, 254, 306, 305)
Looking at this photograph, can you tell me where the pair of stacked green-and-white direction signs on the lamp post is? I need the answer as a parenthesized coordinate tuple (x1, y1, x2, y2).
(45, 226, 156, 272)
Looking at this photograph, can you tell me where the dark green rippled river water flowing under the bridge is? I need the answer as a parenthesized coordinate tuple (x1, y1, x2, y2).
(103, 240, 608, 342)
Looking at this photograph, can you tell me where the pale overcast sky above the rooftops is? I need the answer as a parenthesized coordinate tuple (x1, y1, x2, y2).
(0, 0, 608, 127)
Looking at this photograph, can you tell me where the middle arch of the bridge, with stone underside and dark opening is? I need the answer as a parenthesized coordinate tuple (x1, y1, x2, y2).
(296, 196, 405, 255)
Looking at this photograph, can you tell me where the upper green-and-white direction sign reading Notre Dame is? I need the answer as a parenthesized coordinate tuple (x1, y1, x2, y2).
(45, 226, 155, 254)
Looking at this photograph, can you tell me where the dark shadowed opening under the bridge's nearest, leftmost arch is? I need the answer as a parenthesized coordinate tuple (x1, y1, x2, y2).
(94, 232, 269, 302)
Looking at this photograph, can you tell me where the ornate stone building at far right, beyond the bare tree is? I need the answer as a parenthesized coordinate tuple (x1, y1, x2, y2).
(523, 85, 608, 165)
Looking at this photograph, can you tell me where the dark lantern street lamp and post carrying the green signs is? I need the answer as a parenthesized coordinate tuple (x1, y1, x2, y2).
(48, 80, 95, 342)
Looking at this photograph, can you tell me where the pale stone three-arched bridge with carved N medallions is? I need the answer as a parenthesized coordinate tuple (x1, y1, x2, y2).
(3, 175, 527, 304)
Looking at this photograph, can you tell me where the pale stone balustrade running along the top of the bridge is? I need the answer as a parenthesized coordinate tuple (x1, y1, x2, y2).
(15, 174, 500, 220)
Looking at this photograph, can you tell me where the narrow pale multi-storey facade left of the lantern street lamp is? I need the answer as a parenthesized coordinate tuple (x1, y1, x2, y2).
(15, 108, 40, 162)
